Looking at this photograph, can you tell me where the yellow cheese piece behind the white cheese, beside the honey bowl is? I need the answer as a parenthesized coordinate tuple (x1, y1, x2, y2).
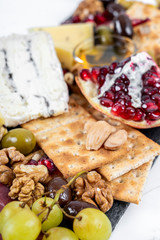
(32, 23, 93, 69)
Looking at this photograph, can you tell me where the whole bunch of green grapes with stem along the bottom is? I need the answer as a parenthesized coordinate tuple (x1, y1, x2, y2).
(0, 172, 112, 240)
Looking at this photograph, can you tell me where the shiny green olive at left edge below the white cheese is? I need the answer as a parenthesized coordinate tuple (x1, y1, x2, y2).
(1, 128, 36, 155)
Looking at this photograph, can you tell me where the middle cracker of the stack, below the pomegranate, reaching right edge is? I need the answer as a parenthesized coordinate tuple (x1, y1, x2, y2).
(72, 94, 160, 181)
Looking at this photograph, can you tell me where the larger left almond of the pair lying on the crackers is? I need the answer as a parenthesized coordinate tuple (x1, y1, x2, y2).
(86, 121, 116, 150)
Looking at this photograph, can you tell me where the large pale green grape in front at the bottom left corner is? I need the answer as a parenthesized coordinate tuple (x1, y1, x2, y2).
(2, 209, 41, 240)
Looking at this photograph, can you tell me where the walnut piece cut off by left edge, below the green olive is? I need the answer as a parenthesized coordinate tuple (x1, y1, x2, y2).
(0, 165, 14, 185)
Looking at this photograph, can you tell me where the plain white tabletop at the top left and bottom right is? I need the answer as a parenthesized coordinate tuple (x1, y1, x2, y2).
(0, 0, 160, 240)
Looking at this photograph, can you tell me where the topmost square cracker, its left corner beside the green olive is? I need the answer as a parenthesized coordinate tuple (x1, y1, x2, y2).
(22, 97, 131, 178)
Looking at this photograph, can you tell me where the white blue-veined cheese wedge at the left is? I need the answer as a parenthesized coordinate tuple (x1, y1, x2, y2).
(0, 32, 69, 127)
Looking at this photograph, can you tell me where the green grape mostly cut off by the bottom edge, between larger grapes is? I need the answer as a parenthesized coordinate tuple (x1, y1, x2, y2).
(42, 227, 78, 240)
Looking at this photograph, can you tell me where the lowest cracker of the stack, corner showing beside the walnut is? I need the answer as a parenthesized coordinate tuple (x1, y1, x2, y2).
(108, 161, 153, 204)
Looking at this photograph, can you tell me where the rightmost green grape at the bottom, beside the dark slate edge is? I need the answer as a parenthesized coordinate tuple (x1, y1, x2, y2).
(73, 208, 112, 240)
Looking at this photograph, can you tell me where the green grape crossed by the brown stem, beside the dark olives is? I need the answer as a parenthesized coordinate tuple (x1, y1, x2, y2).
(32, 197, 63, 231)
